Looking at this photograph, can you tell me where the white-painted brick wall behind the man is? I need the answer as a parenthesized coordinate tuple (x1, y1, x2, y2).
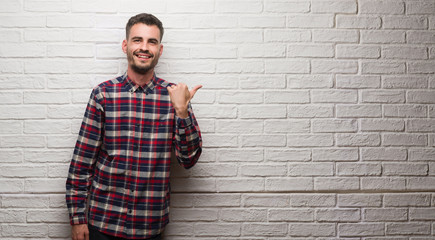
(0, 0, 435, 240)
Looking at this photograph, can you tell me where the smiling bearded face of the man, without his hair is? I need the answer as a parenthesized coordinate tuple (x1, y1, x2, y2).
(122, 23, 163, 74)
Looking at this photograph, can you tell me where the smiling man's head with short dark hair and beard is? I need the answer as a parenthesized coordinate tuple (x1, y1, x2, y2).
(122, 13, 163, 75)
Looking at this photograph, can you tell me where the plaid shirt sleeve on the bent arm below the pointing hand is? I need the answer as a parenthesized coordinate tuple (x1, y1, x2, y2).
(173, 104, 202, 169)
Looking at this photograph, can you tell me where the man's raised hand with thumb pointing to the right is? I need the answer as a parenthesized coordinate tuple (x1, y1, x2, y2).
(167, 83, 202, 118)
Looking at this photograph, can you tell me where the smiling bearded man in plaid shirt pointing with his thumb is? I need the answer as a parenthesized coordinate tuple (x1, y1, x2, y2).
(66, 14, 202, 240)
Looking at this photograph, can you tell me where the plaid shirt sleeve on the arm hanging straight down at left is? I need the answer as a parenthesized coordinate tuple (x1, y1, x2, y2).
(66, 89, 104, 225)
